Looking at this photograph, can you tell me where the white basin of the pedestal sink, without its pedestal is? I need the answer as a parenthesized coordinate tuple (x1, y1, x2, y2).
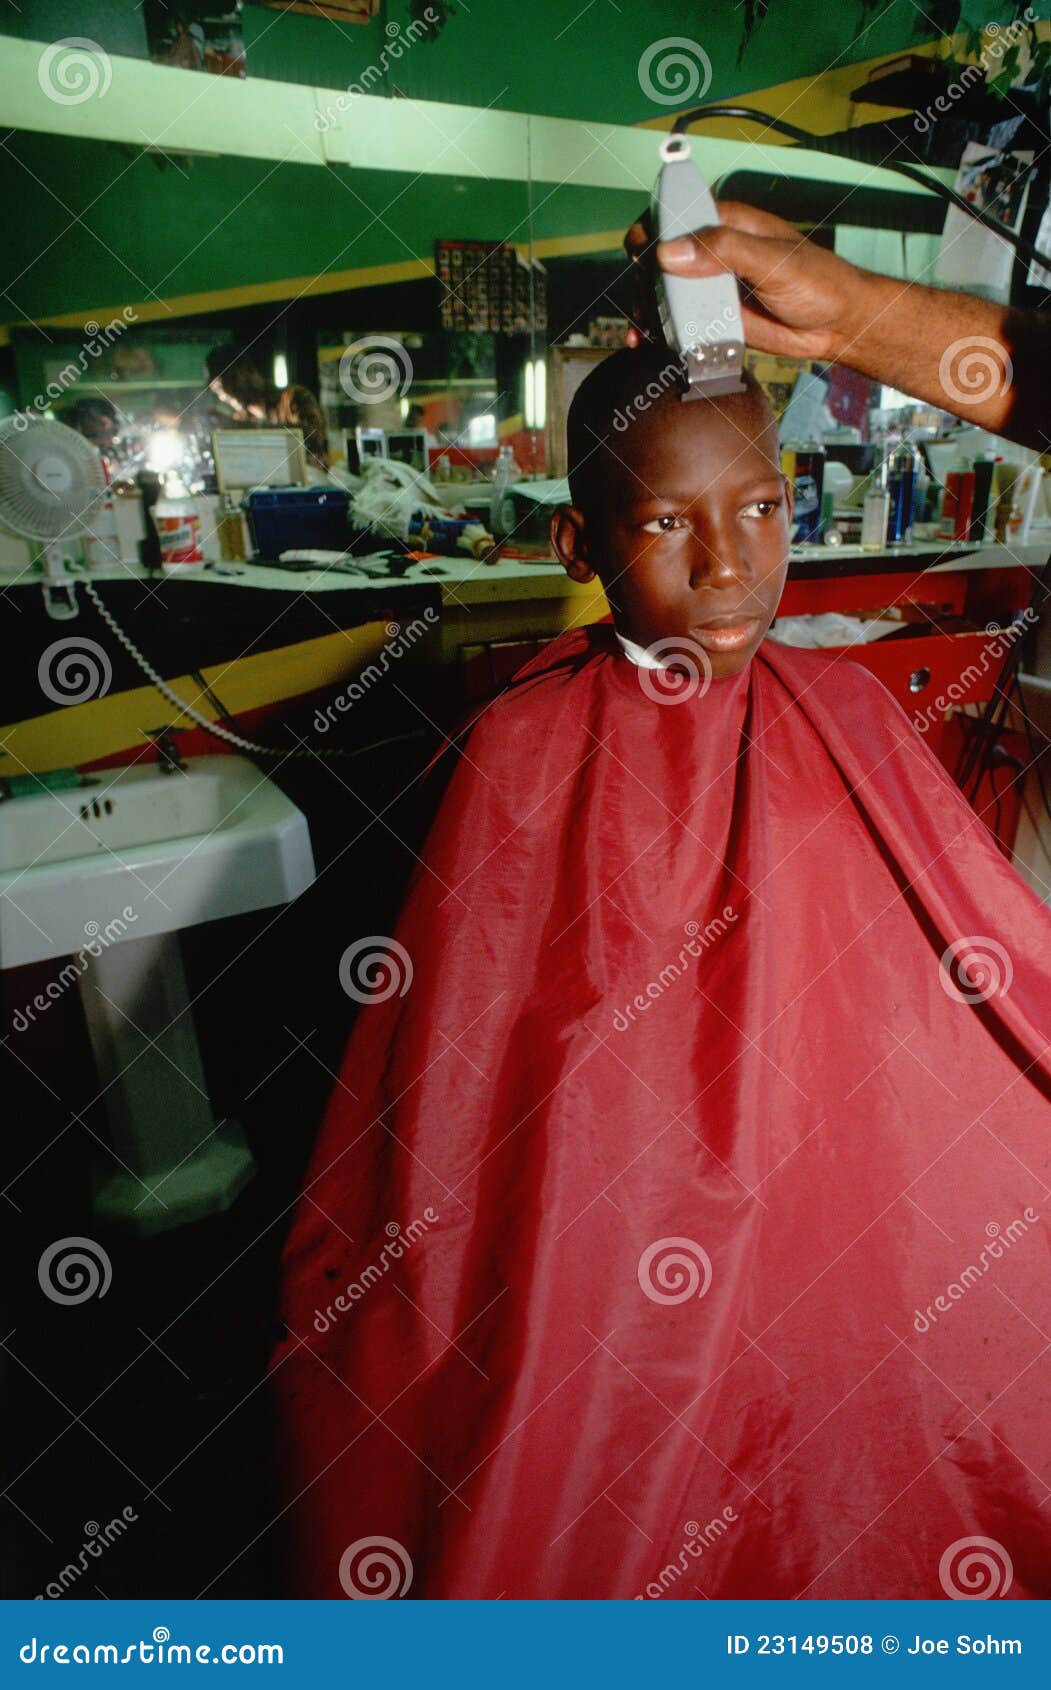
(0, 757, 314, 968)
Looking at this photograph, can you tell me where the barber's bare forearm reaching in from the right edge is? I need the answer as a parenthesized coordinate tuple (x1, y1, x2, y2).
(836, 270, 1051, 451)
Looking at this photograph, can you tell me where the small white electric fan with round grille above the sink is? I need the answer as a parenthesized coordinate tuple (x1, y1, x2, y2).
(0, 414, 106, 619)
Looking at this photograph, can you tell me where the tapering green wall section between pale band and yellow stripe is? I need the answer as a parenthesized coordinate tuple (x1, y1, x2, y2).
(0, 132, 640, 321)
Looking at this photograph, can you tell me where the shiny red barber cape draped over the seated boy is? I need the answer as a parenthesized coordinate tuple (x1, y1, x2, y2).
(272, 627, 1051, 1600)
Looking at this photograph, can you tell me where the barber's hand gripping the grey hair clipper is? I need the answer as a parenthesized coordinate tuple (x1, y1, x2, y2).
(624, 199, 870, 360)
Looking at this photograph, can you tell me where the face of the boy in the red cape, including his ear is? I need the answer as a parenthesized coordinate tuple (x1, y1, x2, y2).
(551, 392, 791, 679)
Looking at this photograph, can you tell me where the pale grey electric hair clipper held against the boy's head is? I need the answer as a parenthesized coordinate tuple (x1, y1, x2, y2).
(652, 135, 745, 399)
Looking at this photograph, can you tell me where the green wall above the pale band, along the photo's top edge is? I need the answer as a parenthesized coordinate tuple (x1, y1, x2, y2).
(0, 0, 1007, 123)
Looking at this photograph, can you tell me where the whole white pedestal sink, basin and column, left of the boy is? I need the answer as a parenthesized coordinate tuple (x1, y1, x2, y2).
(0, 757, 314, 1234)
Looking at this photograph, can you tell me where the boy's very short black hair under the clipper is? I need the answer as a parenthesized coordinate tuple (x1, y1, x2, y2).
(566, 341, 765, 514)
